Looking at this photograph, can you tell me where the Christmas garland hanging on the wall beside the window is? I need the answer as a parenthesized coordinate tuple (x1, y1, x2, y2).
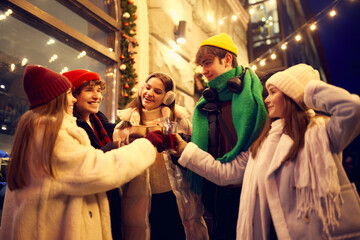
(118, 0, 139, 109)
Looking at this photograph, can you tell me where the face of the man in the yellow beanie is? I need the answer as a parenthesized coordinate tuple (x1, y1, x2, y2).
(200, 53, 232, 81)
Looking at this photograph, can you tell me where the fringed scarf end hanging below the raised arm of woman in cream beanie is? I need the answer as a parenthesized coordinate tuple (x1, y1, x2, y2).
(294, 117, 342, 236)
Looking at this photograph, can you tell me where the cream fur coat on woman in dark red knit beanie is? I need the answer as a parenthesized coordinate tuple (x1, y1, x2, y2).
(0, 115, 156, 240)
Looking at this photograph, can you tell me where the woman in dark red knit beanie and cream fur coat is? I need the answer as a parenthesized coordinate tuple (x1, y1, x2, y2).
(0, 65, 162, 240)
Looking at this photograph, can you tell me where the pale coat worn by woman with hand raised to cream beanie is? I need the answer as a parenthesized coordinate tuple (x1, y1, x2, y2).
(179, 81, 360, 240)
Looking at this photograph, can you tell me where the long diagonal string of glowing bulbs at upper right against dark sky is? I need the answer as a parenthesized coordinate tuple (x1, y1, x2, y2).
(249, 0, 341, 70)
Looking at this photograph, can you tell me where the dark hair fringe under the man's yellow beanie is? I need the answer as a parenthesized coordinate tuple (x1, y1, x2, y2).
(195, 45, 238, 68)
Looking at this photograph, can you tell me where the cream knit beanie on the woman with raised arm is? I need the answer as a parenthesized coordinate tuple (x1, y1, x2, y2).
(266, 63, 320, 107)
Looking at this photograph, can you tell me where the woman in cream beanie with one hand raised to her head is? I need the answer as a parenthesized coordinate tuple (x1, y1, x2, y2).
(173, 64, 360, 240)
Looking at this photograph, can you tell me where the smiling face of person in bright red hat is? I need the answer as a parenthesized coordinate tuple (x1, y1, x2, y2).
(76, 85, 102, 120)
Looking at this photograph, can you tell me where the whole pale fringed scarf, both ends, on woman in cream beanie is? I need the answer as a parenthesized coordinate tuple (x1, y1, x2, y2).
(238, 117, 341, 239)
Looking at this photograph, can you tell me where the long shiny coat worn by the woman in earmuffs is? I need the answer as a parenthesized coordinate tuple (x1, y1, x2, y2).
(113, 108, 209, 240)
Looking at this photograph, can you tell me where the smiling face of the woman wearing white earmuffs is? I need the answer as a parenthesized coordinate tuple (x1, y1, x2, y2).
(140, 77, 166, 110)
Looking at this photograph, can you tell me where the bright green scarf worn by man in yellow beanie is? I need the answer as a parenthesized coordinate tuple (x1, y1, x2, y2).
(187, 66, 267, 194)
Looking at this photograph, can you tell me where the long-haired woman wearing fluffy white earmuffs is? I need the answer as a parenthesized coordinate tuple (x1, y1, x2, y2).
(113, 72, 209, 240)
